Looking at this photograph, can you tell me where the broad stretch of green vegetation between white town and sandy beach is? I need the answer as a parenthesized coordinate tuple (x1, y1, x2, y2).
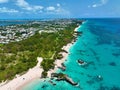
(0, 23, 79, 82)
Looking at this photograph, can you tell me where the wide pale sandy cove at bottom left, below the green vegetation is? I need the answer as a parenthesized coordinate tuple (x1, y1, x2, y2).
(0, 57, 43, 90)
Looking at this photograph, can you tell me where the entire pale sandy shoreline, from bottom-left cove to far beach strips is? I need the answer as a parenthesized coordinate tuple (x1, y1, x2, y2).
(0, 26, 80, 90)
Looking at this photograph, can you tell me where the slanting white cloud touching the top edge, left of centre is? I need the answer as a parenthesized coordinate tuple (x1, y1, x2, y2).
(16, 0, 44, 11)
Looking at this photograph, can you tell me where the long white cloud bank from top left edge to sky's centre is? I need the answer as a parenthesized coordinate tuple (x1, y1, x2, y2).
(15, 0, 69, 15)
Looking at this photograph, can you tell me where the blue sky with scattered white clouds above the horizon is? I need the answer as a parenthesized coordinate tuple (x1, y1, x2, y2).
(0, 0, 120, 19)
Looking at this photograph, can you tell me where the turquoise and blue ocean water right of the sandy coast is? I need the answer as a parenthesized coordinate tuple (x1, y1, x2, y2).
(23, 19, 120, 90)
